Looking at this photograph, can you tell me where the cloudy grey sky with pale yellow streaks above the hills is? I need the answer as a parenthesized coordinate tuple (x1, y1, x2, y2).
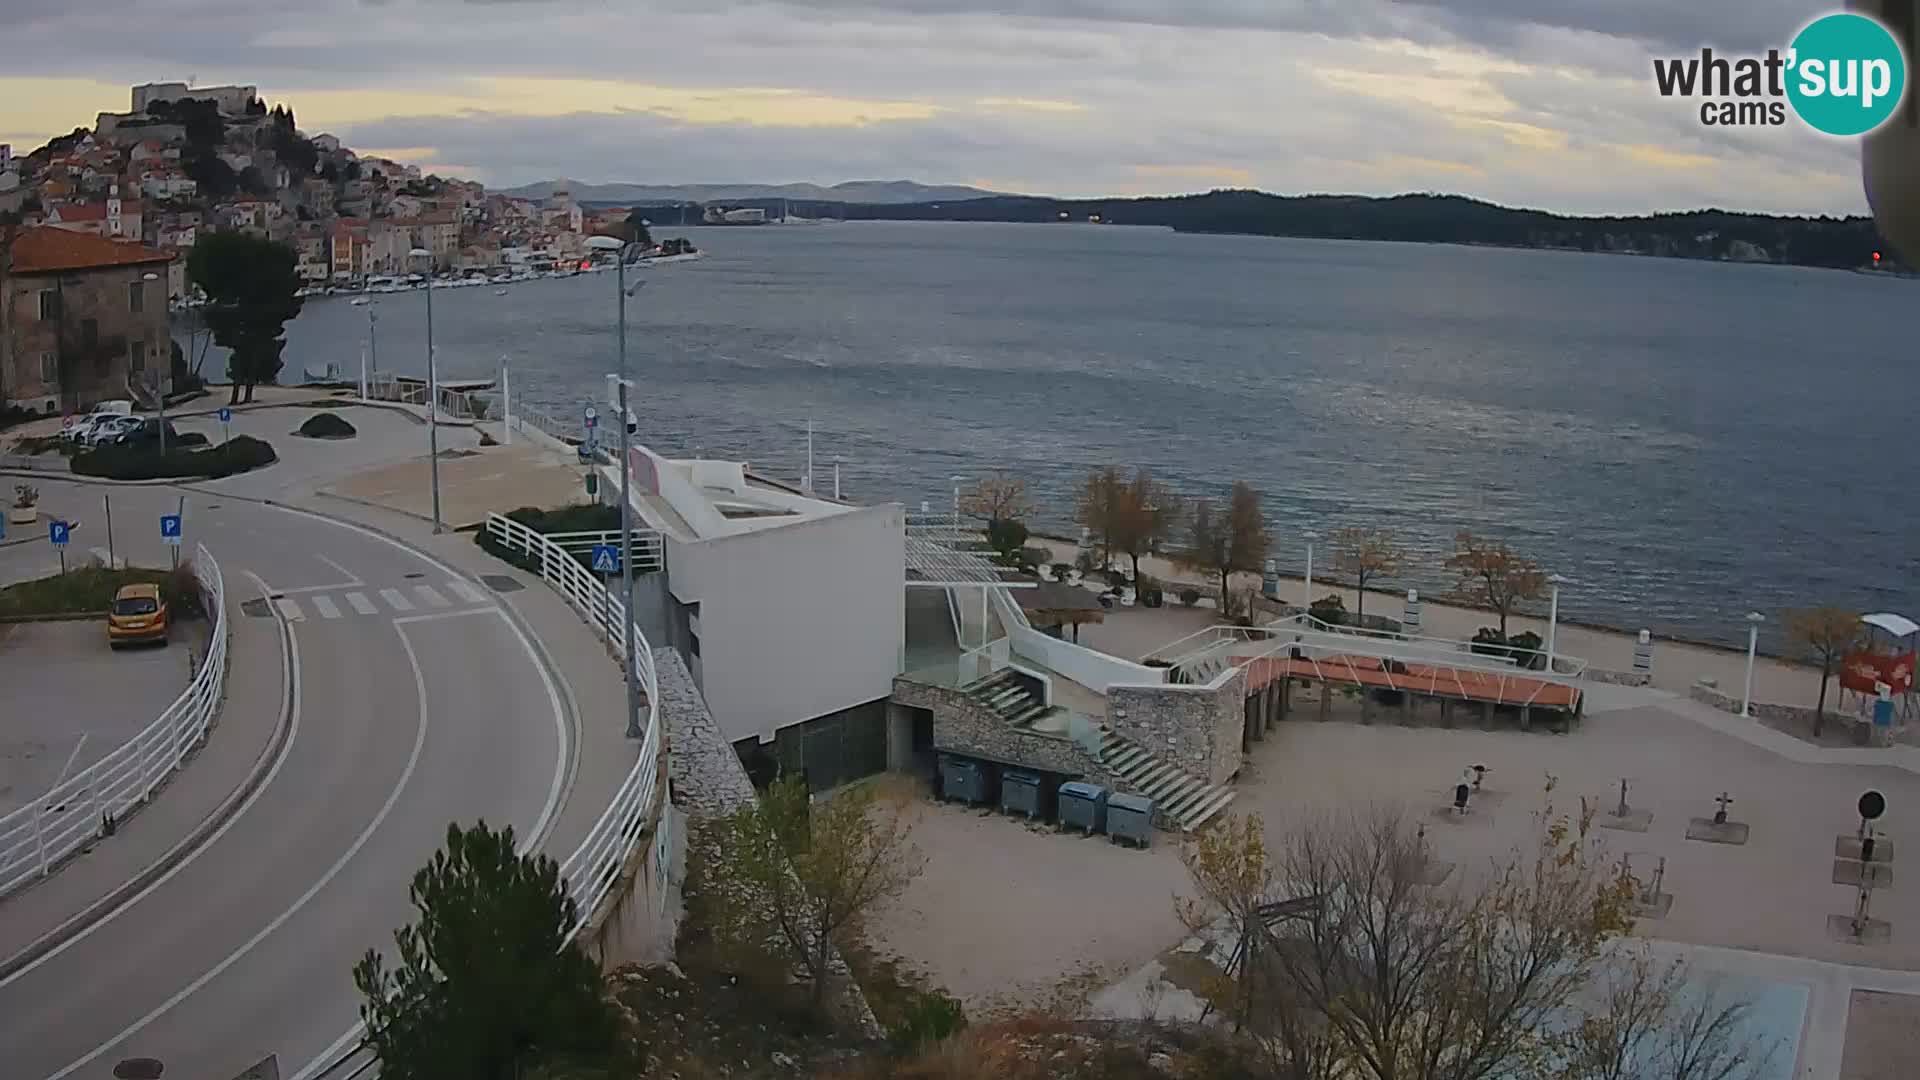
(0, 0, 1866, 213)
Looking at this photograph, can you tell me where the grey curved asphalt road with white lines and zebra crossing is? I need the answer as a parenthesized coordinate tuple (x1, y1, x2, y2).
(0, 484, 574, 1080)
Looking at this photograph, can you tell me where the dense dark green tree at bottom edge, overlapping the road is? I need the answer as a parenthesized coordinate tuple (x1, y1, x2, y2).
(353, 822, 616, 1080)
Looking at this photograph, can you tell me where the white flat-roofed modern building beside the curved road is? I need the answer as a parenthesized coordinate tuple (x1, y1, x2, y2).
(601, 438, 906, 786)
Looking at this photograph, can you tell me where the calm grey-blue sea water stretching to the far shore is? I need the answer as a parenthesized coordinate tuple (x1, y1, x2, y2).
(259, 223, 1920, 644)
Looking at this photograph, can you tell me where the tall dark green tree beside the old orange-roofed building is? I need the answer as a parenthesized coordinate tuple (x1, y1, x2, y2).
(186, 233, 300, 405)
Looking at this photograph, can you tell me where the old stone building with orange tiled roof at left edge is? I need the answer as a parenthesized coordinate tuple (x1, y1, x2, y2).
(0, 227, 173, 413)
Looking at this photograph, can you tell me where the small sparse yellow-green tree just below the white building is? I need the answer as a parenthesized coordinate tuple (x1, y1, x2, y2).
(708, 776, 925, 1007)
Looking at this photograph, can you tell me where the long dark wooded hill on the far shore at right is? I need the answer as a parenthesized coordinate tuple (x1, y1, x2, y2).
(837, 190, 1903, 269)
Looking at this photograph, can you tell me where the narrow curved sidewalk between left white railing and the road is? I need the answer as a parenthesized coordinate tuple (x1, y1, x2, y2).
(0, 577, 286, 976)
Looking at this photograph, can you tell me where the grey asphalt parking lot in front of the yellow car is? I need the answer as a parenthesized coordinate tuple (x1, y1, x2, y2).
(0, 619, 205, 813)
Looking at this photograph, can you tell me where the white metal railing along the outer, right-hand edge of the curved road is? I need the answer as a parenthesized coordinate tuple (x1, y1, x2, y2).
(486, 513, 660, 930)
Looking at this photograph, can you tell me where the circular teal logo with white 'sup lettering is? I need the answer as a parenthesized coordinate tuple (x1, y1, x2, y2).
(1788, 12, 1907, 135)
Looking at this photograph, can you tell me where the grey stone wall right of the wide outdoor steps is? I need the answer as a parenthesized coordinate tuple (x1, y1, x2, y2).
(1106, 667, 1246, 784)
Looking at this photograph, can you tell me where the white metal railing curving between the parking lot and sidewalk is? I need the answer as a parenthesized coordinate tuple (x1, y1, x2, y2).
(0, 546, 228, 896)
